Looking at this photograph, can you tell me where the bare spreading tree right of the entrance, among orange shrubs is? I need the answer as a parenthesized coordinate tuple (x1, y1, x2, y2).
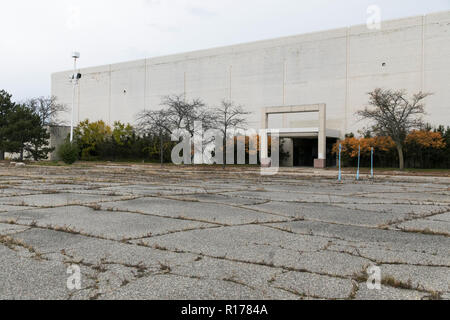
(357, 88, 431, 170)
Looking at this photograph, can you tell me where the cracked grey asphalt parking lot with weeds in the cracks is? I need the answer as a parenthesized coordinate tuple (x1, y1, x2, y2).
(0, 164, 450, 300)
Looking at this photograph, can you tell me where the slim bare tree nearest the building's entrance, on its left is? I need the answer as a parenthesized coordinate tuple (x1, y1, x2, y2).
(213, 100, 250, 168)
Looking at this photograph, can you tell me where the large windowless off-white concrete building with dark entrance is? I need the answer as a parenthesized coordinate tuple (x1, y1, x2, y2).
(52, 11, 450, 166)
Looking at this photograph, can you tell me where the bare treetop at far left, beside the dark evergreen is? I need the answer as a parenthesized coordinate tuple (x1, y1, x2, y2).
(25, 96, 68, 126)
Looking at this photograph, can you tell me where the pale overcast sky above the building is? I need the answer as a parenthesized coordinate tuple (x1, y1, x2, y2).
(0, 0, 450, 101)
